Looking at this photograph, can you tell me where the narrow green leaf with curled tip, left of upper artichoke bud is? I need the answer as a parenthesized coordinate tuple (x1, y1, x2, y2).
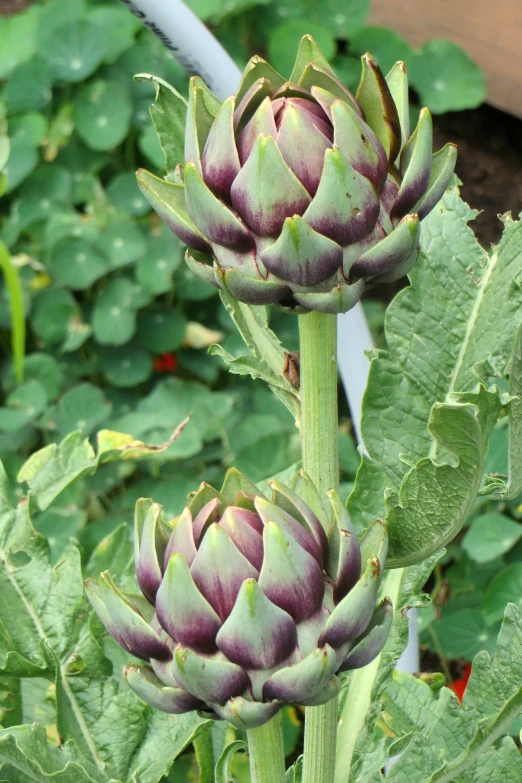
(136, 73, 187, 181)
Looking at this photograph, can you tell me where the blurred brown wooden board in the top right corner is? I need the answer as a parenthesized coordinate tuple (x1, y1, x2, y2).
(369, 0, 522, 117)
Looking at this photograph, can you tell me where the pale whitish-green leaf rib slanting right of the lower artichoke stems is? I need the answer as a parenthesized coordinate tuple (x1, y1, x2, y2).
(335, 568, 404, 783)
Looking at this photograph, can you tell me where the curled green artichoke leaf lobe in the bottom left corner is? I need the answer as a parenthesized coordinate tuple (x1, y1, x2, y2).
(0, 724, 108, 783)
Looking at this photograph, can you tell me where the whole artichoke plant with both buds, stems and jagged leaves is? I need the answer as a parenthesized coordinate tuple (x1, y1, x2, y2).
(0, 30, 522, 783)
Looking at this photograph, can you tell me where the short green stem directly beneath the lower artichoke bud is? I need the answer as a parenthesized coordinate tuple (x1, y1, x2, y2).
(247, 712, 285, 783)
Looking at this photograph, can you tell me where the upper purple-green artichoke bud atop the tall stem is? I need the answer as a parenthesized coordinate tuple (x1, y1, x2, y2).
(138, 36, 456, 313)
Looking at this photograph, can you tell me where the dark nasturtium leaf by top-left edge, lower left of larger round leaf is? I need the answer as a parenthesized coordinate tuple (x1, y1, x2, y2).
(4, 57, 52, 114)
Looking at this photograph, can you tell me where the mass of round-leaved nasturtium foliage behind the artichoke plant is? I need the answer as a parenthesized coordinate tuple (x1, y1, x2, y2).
(0, 0, 522, 781)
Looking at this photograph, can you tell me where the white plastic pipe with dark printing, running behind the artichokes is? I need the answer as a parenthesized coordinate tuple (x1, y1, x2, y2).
(121, 0, 419, 673)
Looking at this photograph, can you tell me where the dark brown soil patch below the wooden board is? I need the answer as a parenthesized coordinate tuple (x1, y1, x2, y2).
(435, 106, 522, 246)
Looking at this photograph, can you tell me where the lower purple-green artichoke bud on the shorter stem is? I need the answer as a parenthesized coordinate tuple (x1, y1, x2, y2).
(87, 469, 393, 728)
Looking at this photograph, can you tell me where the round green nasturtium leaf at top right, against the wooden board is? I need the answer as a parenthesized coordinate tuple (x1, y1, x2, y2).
(409, 41, 486, 114)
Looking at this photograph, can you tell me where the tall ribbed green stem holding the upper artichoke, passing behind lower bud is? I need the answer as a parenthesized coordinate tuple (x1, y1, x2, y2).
(299, 312, 339, 783)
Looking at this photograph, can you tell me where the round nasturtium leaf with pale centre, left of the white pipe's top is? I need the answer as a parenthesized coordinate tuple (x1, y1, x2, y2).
(44, 19, 105, 82)
